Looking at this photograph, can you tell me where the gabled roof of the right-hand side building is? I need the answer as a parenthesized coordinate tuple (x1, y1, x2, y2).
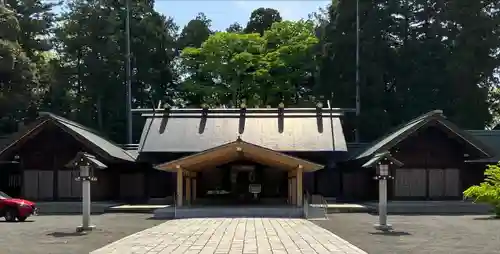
(352, 110, 493, 159)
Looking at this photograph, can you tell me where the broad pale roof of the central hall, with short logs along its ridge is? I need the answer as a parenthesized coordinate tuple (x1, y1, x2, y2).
(139, 108, 347, 153)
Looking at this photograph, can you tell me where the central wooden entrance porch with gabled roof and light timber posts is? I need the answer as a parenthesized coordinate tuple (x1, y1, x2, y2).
(156, 139, 323, 208)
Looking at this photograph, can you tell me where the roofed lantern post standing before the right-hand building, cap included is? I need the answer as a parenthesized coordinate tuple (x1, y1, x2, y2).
(362, 151, 403, 232)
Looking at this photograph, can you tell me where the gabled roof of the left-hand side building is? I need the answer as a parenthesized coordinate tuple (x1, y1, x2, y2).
(0, 112, 135, 161)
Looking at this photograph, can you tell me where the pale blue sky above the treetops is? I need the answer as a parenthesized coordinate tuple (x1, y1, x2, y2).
(155, 0, 330, 30)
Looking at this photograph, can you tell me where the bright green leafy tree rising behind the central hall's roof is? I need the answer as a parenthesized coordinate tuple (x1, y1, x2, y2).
(181, 21, 317, 106)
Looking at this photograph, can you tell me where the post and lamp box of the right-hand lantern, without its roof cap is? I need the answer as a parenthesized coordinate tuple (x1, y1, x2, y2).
(375, 164, 392, 232)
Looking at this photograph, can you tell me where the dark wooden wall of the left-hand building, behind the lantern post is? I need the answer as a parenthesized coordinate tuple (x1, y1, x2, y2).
(11, 124, 146, 201)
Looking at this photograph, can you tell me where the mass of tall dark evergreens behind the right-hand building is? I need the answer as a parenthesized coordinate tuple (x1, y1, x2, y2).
(316, 0, 500, 141)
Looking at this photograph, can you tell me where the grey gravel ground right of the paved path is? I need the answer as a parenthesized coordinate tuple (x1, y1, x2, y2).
(314, 213, 500, 254)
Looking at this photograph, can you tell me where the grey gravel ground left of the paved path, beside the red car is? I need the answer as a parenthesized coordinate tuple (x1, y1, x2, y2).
(0, 213, 164, 254)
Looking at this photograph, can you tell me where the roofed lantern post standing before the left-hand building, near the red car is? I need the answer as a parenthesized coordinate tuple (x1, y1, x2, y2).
(67, 152, 107, 232)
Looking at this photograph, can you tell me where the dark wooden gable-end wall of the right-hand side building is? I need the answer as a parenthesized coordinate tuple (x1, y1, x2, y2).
(390, 125, 480, 200)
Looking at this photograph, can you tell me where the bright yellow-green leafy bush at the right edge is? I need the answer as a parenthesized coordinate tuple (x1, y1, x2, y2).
(464, 163, 500, 217)
